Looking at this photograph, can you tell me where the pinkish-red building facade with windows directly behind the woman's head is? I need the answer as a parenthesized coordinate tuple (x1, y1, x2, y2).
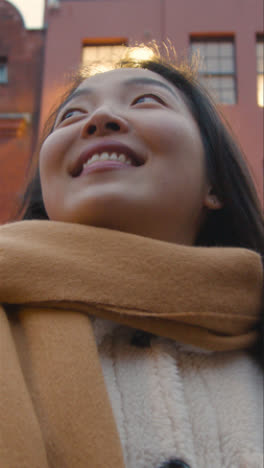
(41, 0, 263, 199)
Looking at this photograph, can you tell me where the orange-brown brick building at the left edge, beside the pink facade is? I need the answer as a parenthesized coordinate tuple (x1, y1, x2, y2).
(0, 0, 44, 222)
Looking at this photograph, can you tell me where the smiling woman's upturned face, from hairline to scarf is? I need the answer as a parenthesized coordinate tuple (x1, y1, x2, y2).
(40, 68, 216, 245)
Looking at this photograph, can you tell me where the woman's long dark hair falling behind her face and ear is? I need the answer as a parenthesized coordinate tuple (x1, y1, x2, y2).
(14, 52, 264, 354)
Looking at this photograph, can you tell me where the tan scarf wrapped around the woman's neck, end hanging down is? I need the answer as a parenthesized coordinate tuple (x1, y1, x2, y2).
(0, 221, 263, 468)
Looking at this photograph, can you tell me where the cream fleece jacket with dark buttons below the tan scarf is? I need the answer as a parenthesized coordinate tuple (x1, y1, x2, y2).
(93, 318, 263, 468)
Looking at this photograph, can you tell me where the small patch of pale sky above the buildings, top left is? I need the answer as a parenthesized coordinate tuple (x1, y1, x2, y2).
(8, 0, 44, 29)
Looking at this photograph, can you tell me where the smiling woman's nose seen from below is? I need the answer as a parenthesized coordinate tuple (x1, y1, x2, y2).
(82, 108, 129, 138)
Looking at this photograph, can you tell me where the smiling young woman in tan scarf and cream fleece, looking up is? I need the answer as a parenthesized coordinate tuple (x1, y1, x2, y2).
(0, 51, 264, 468)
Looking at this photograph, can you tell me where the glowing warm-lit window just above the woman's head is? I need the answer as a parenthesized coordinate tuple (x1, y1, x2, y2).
(82, 38, 153, 74)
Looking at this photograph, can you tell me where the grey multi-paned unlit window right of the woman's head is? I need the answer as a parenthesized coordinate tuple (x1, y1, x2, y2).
(191, 37, 236, 104)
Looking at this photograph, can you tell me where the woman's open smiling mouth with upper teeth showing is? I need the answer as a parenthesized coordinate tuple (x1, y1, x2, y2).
(70, 141, 145, 177)
